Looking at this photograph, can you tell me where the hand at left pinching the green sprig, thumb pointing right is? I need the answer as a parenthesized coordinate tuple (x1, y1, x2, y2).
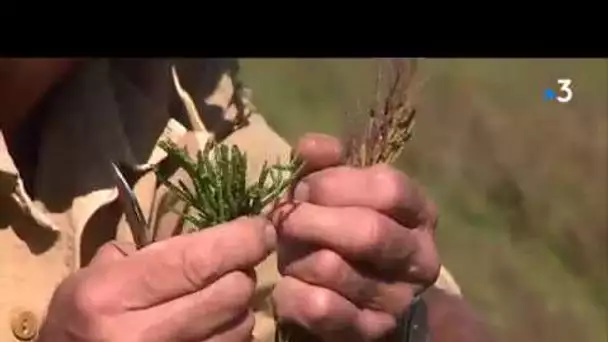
(38, 218, 276, 342)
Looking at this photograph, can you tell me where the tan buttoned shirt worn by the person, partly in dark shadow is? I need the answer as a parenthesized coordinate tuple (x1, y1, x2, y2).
(0, 59, 459, 342)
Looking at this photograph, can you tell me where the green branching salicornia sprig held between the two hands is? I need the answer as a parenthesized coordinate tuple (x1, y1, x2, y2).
(158, 140, 302, 229)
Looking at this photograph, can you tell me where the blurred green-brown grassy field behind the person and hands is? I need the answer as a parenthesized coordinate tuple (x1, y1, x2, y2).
(241, 59, 608, 342)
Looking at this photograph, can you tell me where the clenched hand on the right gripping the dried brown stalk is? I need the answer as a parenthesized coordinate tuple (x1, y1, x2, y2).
(273, 135, 440, 342)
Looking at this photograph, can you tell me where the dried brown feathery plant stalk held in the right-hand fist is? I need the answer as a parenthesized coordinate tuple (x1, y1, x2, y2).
(275, 59, 417, 342)
